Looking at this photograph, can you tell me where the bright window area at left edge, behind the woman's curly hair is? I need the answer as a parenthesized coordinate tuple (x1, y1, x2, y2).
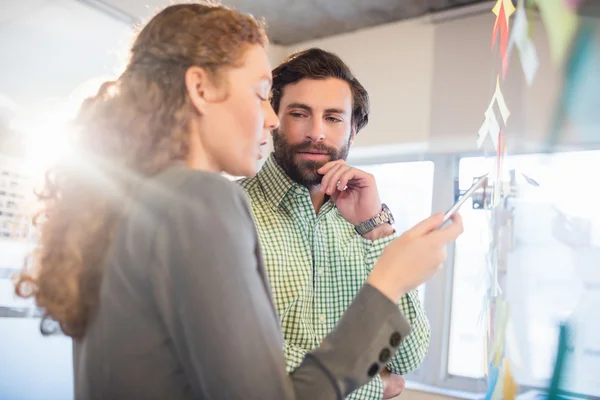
(0, 155, 73, 400)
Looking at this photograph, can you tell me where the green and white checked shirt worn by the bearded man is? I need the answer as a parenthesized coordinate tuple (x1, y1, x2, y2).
(240, 155, 430, 400)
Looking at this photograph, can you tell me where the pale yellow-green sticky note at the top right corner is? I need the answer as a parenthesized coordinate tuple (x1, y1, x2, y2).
(534, 0, 577, 64)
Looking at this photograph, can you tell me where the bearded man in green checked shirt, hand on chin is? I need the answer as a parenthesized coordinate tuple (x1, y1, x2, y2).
(241, 49, 430, 399)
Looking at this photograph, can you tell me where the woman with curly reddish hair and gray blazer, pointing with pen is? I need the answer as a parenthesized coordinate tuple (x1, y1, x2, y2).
(17, 4, 462, 400)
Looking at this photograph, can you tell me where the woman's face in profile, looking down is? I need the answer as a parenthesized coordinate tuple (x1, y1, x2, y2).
(192, 45, 279, 176)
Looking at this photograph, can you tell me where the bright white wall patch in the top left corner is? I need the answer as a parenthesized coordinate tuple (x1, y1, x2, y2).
(0, 0, 132, 108)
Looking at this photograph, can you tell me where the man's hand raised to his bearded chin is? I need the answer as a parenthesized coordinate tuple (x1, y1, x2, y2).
(317, 160, 381, 225)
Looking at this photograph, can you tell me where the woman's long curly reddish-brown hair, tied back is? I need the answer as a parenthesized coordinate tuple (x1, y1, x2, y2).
(15, 2, 267, 338)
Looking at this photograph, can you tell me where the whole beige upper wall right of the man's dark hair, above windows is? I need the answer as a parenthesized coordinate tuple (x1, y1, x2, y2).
(287, 7, 596, 154)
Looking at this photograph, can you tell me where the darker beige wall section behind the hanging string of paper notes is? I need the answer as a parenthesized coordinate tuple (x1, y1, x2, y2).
(429, 12, 562, 150)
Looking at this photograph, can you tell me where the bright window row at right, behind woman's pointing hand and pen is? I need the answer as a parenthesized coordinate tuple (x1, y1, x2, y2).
(359, 151, 600, 397)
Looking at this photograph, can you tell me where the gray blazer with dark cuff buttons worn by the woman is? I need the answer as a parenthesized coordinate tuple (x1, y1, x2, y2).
(74, 165, 410, 400)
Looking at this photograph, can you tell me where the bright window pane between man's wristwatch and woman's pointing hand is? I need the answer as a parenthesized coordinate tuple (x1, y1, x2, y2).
(359, 161, 434, 304)
